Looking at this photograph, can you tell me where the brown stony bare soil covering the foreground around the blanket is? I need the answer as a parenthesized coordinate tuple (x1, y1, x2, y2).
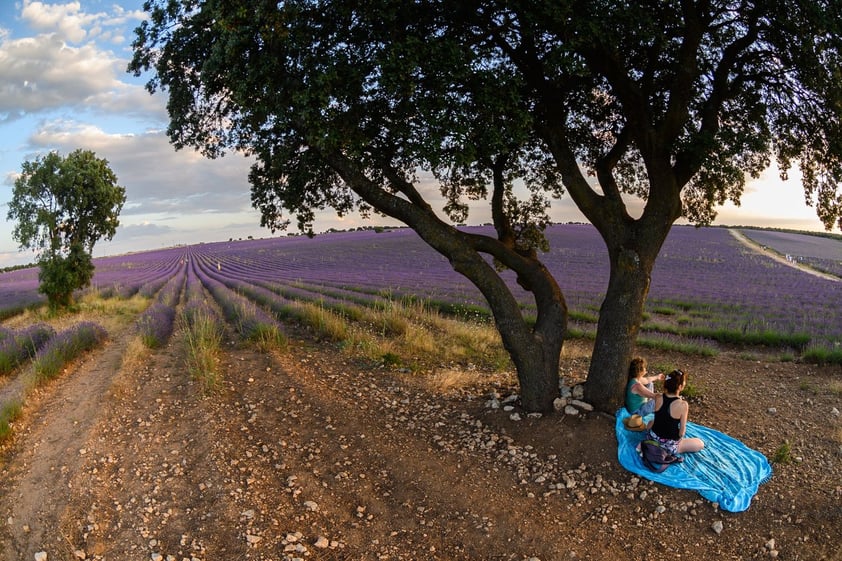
(0, 312, 842, 561)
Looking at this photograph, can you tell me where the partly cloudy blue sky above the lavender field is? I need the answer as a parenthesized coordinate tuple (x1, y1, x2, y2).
(0, 0, 823, 268)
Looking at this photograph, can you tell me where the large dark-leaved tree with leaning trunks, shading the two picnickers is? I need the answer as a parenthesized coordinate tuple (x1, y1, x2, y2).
(129, 0, 842, 412)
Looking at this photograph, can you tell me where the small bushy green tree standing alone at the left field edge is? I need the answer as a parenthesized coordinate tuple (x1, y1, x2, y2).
(7, 150, 126, 308)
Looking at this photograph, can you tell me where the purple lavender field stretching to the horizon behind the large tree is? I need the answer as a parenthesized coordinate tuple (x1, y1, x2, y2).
(0, 224, 842, 364)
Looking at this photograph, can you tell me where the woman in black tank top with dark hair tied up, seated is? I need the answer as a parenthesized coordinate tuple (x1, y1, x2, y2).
(649, 370, 705, 454)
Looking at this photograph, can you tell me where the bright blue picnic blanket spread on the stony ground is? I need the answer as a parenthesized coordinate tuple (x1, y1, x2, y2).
(614, 407, 772, 512)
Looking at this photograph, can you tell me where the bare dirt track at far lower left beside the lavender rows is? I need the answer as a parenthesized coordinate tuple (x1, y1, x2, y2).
(0, 328, 132, 561)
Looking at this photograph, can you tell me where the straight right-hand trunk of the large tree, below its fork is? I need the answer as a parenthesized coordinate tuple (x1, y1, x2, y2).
(585, 244, 654, 415)
